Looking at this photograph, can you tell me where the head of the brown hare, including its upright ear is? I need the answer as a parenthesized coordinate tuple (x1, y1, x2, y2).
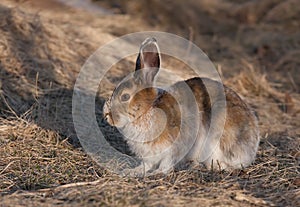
(103, 38, 160, 128)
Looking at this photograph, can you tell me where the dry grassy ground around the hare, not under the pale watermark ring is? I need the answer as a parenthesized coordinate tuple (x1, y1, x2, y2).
(0, 0, 300, 206)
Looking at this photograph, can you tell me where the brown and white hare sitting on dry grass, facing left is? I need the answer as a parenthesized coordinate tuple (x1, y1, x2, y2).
(103, 38, 259, 175)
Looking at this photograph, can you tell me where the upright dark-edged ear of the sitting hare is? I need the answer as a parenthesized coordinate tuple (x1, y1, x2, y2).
(134, 38, 160, 84)
